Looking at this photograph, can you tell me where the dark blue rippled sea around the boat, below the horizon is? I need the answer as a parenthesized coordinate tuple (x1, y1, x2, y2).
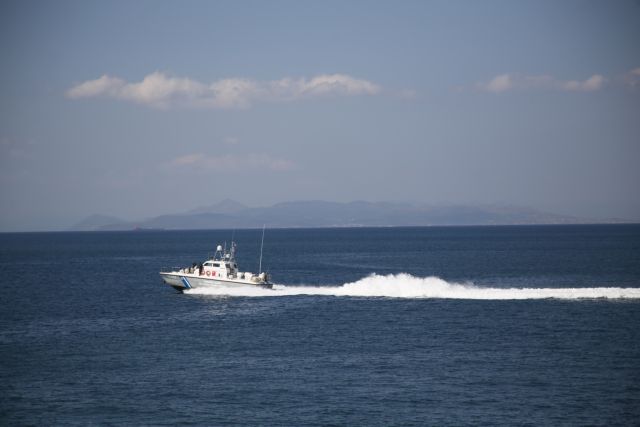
(0, 225, 640, 426)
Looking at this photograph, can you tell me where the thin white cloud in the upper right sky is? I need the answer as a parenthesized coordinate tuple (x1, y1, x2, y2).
(476, 74, 607, 93)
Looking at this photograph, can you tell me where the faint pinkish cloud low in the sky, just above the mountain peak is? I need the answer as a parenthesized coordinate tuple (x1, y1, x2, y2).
(170, 153, 294, 171)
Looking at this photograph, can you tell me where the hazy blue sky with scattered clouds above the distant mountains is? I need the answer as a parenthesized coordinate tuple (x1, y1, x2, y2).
(0, 0, 640, 231)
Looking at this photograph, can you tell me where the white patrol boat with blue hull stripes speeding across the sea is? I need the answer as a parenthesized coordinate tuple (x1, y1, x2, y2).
(160, 242, 273, 292)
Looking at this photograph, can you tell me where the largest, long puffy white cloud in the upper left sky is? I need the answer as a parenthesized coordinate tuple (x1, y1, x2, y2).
(66, 72, 381, 108)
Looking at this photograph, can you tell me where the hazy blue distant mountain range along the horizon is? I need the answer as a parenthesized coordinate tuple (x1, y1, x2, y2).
(71, 199, 620, 231)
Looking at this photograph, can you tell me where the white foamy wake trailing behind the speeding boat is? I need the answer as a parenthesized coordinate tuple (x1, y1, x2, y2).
(186, 273, 640, 300)
